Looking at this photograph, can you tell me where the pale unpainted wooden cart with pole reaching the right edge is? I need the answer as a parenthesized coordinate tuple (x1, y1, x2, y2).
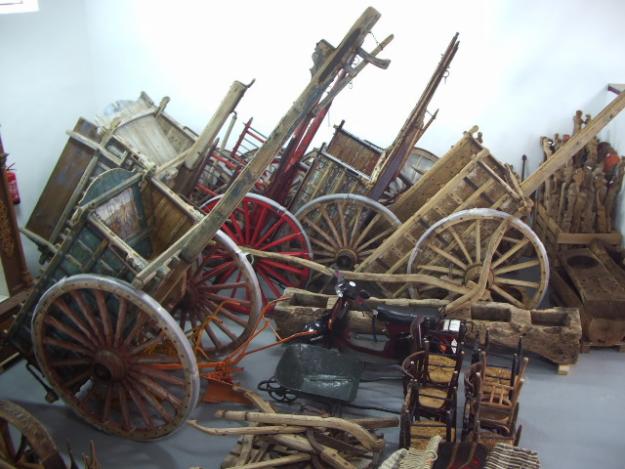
(252, 93, 625, 310)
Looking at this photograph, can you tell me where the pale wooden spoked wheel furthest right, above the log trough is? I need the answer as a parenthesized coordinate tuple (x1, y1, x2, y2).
(407, 208, 549, 309)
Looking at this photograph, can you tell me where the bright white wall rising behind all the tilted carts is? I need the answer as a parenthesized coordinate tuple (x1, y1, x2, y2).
(0, 0, 625, 270)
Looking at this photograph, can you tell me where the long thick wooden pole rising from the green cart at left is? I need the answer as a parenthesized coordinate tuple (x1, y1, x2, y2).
(133, 7, 388, 286)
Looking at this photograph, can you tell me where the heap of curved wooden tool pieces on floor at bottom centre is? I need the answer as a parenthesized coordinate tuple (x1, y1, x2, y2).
(189, 388, 399, 469)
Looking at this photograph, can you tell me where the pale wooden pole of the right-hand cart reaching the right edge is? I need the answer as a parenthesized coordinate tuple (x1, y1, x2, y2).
(521, 92, 625, 197)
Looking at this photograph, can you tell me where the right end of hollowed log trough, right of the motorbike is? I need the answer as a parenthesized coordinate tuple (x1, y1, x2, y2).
(449, 303, 582, 365)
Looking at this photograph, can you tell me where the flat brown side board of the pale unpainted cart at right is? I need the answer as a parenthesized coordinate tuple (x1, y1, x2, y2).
(389, 126, 483, 221)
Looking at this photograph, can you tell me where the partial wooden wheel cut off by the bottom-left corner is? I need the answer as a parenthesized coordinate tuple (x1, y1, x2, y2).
(0, 401, 67, 469)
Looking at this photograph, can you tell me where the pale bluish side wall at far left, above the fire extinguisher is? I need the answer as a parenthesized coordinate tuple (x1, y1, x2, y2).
(0, 0, 95, 272)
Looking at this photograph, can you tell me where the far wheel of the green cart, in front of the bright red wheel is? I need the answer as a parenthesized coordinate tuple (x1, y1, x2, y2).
(171, 230, 262, 355)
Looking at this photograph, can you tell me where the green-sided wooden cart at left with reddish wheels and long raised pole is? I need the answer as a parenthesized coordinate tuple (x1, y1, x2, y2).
(4, 8, 380, 440)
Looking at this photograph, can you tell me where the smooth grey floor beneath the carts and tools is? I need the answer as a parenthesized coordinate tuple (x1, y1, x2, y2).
(0, 335, 625, 469)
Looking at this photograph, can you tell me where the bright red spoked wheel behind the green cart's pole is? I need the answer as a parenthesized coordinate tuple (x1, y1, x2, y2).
(202, 194, 312, 302)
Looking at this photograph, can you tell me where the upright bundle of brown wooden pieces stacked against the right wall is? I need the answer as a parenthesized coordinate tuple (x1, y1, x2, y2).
(538, 111, 625, 252)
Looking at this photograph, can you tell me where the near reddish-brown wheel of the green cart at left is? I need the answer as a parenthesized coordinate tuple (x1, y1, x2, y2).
(32, 274, 200, 440)
